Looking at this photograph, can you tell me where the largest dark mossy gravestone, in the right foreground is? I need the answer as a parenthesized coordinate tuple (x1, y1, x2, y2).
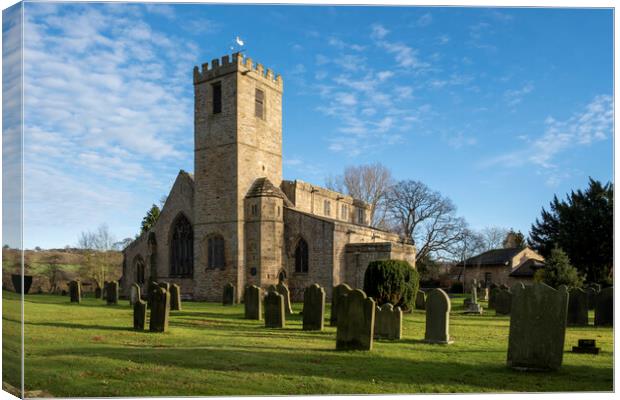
(507, 282, 568, 370)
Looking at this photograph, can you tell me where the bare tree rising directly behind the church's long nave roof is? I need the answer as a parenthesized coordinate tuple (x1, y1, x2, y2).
(325, 163, 392, 227)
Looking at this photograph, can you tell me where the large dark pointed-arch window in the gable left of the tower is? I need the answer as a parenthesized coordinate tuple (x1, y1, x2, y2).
(170, 214, 194, 277)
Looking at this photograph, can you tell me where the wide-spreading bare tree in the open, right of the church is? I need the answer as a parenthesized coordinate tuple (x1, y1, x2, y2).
(386, 180, 467, 260)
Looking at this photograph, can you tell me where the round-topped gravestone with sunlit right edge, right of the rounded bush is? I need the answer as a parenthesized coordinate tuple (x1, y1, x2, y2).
(424, 289, 452, 344)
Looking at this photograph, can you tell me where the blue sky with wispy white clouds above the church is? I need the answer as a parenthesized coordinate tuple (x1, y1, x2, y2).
(7, 3, 613, 248)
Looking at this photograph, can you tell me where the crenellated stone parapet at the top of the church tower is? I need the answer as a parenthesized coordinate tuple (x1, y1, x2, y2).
(194, 53, 283, 90)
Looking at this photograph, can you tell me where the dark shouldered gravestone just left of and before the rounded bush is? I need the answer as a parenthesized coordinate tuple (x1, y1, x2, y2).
(336, 289, 375, 350)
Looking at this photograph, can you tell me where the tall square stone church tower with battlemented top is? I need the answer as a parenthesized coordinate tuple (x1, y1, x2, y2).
(194, 54, 283, 297)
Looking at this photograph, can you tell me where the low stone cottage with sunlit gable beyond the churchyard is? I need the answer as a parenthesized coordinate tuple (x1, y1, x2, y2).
(450, 247, 545, 288)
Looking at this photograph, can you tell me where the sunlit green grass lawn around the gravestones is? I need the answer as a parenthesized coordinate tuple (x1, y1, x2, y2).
(3, 292, 613, 397)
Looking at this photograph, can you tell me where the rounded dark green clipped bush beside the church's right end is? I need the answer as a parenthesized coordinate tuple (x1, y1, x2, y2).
(364, 260, 420, 311)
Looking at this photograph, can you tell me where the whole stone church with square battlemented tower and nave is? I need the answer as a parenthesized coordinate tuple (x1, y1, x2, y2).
(121, 53, 415, 301)
